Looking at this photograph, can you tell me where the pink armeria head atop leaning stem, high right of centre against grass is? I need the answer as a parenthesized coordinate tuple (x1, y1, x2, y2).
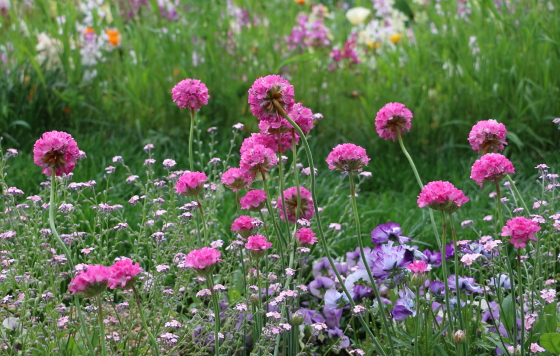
(375, 103, 413, 142)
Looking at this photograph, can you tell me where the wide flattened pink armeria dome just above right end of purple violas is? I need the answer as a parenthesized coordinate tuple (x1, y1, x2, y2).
(417, 180, 469, 213)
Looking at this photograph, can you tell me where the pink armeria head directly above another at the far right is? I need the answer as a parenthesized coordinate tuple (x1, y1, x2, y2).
(469, 120, 507, 154)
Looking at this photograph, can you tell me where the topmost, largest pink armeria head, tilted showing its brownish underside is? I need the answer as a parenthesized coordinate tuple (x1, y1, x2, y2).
(248, 75, 294, 121)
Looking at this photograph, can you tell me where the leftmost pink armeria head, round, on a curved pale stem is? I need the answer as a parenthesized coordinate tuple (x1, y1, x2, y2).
(33, 131, 80, 176)
